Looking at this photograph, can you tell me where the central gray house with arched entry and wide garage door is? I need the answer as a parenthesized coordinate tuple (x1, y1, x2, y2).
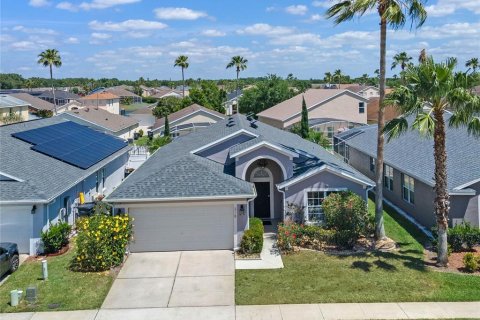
(106, 114, 373, 252)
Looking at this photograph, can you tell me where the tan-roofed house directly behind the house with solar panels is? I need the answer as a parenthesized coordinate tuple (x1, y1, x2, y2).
(61, 107, 138, 140)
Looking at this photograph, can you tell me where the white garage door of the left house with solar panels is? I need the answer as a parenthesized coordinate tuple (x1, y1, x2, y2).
(0, 206, 32, 253)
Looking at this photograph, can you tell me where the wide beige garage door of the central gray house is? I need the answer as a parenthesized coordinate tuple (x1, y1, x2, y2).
(129, 205, 233, 252)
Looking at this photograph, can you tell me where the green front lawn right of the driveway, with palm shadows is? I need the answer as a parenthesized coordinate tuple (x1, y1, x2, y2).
(235, 201, 480, 305)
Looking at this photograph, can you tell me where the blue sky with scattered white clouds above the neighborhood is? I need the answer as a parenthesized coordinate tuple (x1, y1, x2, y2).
(0, 0, 480, 80)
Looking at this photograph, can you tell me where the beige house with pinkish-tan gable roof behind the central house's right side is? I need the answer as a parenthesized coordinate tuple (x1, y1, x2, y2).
(258, 89, 368, 129)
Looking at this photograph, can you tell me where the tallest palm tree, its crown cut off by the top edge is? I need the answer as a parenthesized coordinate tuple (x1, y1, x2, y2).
(327, 0, 427, 239)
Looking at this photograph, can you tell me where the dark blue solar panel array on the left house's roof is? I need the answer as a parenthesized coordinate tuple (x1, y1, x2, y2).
(12, 121, 128, 169)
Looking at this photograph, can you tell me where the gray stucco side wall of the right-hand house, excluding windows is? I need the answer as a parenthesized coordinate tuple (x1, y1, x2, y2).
(348, 147, 480, 227)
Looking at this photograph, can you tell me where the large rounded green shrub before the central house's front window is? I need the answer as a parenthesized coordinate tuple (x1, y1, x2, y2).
(322, 191, 373, 248)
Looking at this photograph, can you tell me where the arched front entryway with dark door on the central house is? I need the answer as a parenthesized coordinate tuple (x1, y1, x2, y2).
(245, 158, 284, 220)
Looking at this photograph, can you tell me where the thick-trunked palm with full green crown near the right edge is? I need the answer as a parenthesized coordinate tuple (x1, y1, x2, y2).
(384, 57, 480, 266)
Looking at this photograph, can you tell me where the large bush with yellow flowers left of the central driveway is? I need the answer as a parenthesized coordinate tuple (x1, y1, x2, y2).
(72, 214, 133, 272)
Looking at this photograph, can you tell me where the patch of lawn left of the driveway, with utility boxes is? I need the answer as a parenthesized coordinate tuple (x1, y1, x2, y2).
(0, 245, 113, 313)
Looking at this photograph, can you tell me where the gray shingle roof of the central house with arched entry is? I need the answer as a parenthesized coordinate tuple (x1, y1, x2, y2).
(107, 115, 373, 201)
